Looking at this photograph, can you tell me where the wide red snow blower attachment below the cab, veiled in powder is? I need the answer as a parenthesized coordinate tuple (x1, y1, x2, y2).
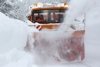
(34, 30, 85, 61)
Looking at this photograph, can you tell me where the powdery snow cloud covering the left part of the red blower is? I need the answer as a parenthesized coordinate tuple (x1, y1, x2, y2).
(31, 31, 72, 64)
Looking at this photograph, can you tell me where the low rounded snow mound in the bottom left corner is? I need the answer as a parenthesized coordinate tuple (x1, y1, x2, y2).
(0, 48, 33, 67)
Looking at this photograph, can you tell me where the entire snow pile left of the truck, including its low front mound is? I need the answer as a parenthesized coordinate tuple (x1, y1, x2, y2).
(0, 13, 37, 67)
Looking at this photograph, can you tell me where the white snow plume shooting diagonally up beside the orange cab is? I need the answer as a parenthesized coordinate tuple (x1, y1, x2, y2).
(58, 0, 88, 31)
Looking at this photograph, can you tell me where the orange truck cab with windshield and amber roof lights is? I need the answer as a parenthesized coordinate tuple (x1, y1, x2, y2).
(29, 3, 68, 30)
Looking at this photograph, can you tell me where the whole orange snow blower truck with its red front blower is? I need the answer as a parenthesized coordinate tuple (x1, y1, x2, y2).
(28, 3, 85, 61)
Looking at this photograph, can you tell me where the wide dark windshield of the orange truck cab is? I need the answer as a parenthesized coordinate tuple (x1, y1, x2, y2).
(32, 10, 65, 23)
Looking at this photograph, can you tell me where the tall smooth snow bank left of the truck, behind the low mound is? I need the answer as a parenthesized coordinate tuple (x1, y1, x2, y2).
(0, 13, 29, 53)
